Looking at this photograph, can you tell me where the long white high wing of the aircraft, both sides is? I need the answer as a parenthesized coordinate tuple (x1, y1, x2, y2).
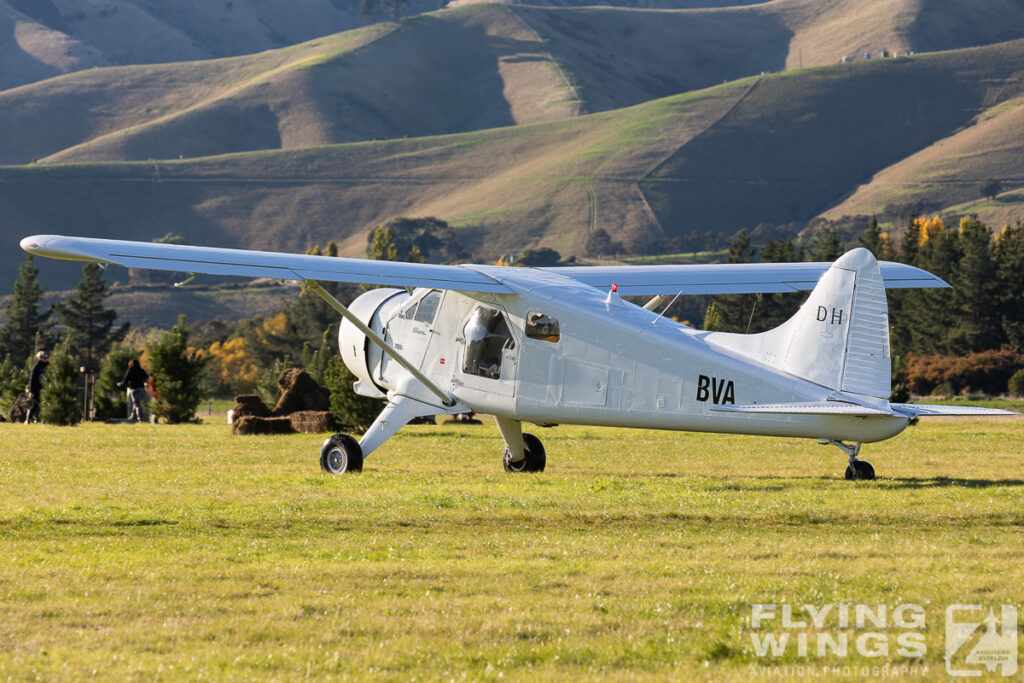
(22, 234, 949, 296)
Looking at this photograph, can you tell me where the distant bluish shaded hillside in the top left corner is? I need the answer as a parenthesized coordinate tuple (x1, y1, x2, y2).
(0, 0, 437, 89)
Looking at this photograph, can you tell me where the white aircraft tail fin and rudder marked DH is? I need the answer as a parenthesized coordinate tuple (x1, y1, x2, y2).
(706, 249, 892, 398)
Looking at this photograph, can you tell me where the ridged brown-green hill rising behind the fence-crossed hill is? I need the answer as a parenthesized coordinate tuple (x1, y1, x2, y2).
(6, 0, 1024, 164)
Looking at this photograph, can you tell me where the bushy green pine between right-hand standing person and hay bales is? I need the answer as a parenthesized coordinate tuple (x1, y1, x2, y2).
(145, 315, 208, 424)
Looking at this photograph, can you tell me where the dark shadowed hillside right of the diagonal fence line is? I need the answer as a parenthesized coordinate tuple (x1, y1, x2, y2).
(641, 41, 1024, 237)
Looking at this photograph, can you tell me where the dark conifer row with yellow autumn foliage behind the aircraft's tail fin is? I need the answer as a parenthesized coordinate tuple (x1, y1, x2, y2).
(703, 216, 1024, 393)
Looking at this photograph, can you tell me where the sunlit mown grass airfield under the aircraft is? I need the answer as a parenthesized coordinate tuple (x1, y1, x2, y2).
(0, 418, 1024, 680)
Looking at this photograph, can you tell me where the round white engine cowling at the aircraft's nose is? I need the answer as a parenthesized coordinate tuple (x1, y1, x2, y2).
(338, 288, 409, 398)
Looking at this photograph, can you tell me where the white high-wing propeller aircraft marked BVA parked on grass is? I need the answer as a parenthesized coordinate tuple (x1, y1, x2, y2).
(22, 236, 1014, 479)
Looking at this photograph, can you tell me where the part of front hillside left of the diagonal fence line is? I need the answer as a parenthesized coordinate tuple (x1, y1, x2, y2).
(0, 83, 750, 284)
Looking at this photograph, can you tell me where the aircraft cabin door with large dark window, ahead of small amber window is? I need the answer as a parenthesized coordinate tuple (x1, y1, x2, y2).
(453, 304, 519, 396)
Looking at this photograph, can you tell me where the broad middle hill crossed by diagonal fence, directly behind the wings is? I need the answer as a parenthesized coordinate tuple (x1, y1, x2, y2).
(6, 41, 1024, 294)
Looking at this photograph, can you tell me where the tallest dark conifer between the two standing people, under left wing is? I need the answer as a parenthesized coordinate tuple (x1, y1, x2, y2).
(54, 263, 129, 367)
